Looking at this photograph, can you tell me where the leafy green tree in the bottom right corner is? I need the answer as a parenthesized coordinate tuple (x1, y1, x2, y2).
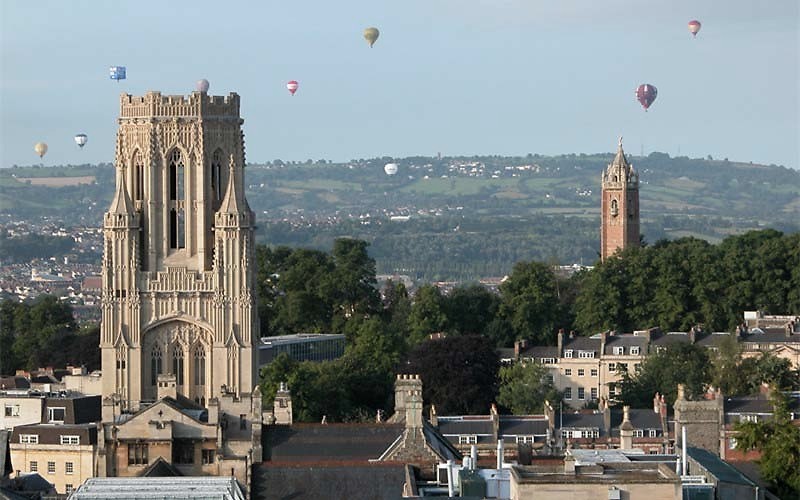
(734, 390, 800, 498)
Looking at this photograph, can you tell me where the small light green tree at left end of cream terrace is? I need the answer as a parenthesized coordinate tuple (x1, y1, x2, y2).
(497, 363, 561, 415)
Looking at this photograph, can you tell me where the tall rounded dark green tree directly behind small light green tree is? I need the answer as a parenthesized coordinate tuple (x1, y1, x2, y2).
(500, 262, 559, 344)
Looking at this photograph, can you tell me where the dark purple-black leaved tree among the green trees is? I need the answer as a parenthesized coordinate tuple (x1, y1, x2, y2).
(403, 335, 500, 415)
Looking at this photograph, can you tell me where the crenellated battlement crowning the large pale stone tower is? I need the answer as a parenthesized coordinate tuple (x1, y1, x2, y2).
(119, 91, 239, 121)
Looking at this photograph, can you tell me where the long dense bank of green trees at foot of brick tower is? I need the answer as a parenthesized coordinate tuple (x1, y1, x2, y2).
(574, 229, 800, 333)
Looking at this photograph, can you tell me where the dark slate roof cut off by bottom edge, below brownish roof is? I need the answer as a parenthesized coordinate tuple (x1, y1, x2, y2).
(251, 462, 405, 500)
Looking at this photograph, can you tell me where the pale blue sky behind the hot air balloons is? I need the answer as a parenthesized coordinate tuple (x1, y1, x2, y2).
(0, 0, 800, 169)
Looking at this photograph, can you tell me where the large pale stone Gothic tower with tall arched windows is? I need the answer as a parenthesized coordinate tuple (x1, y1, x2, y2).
(100, 92, 259, 412)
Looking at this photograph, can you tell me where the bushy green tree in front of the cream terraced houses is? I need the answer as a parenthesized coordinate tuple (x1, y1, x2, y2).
(621, 342, 710, 408)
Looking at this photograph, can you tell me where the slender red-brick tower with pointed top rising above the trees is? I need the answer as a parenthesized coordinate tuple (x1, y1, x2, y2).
(600, 137, 639, 260)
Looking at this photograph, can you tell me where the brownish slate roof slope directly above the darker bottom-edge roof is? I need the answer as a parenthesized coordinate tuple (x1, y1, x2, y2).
(263, 424, 404, 464)
